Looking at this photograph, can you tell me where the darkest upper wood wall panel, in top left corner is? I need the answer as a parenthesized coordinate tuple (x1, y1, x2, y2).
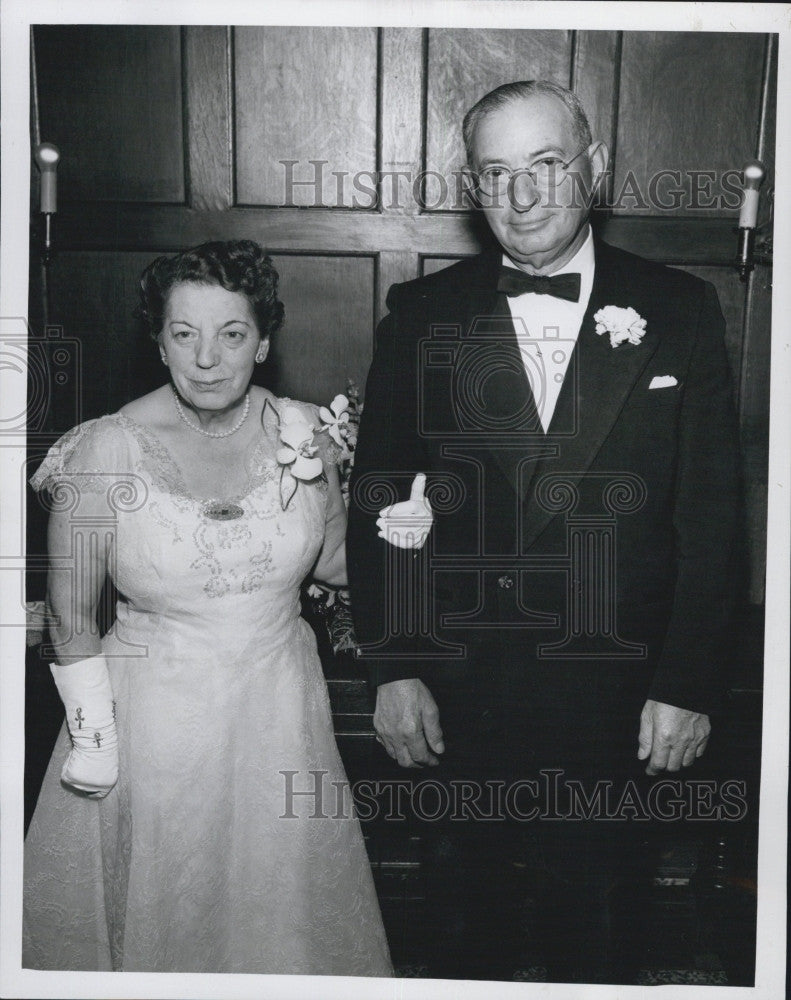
(35, 25, 185, 203)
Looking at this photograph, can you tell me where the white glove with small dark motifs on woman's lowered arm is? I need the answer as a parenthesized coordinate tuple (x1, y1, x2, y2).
(50, 656, 118, 799)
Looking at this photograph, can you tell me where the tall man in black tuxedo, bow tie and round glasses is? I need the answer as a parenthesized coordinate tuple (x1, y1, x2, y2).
(347, 81, 738, 982)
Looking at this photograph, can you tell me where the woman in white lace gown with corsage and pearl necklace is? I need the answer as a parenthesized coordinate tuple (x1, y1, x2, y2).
(23, 241, 392, 976)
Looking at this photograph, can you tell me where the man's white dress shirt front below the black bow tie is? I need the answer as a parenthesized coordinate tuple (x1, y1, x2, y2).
(503, 226, 595, 431)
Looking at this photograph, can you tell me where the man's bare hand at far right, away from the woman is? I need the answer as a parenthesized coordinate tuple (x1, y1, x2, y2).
(637, 698, 711, 774)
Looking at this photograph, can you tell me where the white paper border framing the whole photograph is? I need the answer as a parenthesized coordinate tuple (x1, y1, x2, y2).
(0, 0, 791, 1000)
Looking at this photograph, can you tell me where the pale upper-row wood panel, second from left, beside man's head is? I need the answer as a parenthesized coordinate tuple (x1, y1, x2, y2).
(234, 28, 377, 208)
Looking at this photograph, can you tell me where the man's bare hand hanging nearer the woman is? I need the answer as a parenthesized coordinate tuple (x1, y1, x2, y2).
(374, 677, 445, 767)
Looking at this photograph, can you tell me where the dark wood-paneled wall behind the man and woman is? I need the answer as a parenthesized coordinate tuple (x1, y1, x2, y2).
(30, 26, 774, 603)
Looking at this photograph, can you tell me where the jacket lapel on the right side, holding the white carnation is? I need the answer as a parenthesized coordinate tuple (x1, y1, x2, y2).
(523, 241, 659, 546)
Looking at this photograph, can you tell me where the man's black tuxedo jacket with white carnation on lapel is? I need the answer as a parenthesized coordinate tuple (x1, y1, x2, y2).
(347, 242, 739, 717)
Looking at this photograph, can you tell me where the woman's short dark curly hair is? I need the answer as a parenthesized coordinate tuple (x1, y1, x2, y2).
(137, 240, 284, 340)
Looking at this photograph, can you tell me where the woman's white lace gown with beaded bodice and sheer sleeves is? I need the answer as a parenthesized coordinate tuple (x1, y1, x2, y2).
(23, 400, 392, 976)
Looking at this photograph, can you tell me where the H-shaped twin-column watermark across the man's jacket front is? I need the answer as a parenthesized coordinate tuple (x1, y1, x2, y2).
(353, 464, 648, 661)
